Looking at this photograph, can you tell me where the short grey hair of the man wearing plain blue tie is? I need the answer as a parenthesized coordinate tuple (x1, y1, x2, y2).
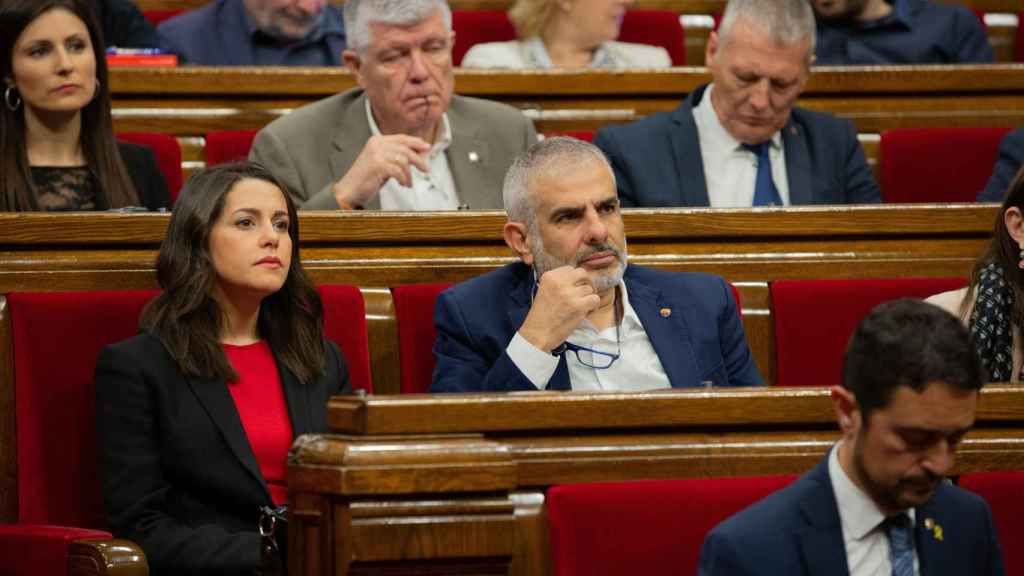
(718, 0, 817, 57)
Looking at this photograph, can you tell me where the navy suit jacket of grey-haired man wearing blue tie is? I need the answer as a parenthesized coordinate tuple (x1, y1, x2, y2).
(594, 86, 882, 207)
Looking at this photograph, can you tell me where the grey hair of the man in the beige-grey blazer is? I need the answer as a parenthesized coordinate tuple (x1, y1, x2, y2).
(343, 0, 452, 52)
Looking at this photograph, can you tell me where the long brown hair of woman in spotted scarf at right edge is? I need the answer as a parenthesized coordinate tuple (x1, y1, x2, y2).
(959, 168, 1024, 326)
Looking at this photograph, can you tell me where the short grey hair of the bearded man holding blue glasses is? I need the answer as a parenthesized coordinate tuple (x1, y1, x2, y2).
(502, 136, 615, 233)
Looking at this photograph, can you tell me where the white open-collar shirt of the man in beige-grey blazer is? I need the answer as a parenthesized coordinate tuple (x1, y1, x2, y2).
(367, 98, 459, 211)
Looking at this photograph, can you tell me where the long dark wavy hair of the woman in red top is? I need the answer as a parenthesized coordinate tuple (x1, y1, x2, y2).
(139, 162, 325, 382)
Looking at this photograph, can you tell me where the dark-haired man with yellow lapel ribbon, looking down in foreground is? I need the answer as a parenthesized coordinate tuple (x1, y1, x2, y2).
(699, 299, 1005, 576)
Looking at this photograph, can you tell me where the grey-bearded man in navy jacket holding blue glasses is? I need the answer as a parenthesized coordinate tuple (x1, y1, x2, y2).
(430, 137, 762, 392)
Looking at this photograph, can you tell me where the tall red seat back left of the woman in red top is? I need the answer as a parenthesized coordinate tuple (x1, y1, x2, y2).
(8, 290, 157, 528)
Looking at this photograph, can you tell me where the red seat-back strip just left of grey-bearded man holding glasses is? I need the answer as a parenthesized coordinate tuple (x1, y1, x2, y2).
(391, 284, 451, 394)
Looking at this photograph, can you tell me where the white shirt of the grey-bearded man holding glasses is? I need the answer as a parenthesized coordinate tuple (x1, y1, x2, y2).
(506, 282, 672, 390)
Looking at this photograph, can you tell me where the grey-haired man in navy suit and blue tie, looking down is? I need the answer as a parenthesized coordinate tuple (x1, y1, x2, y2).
(594, 0, 881, 207)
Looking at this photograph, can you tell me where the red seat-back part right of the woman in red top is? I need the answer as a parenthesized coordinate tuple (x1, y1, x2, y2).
(317, 286, 374, 393)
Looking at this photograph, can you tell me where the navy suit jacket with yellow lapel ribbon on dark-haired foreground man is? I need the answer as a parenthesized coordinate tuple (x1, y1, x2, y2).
(698, 457, 1004, 576)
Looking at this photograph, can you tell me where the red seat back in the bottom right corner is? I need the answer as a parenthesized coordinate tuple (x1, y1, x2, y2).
(959, 471, 1024, 574)
